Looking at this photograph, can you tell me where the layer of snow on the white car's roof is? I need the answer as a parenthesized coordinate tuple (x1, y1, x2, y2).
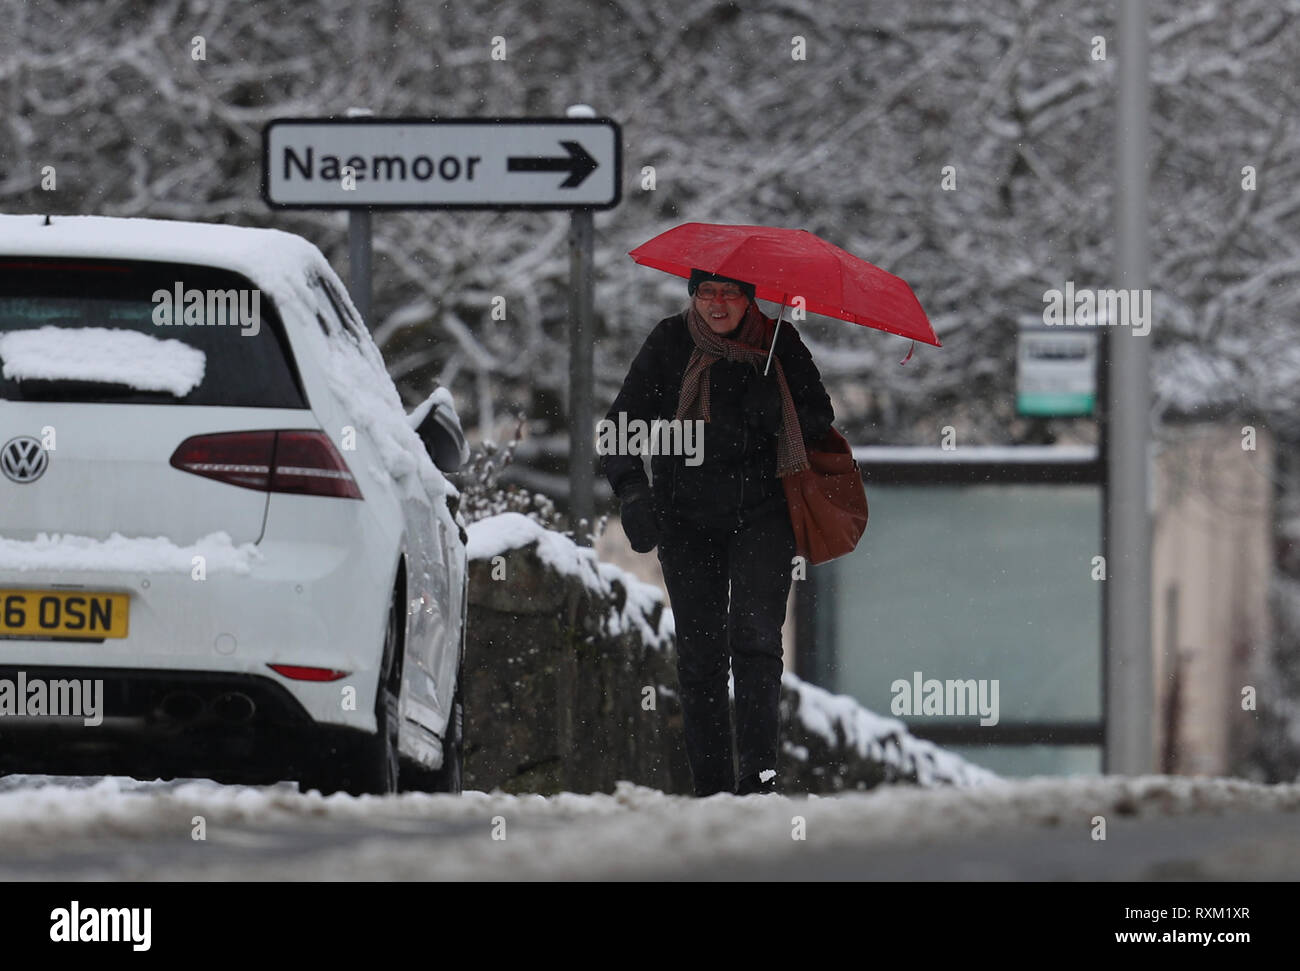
(0, 216, 324, 290)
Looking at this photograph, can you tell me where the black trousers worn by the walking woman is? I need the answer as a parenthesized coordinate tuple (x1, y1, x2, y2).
(659, 504, 794, 796)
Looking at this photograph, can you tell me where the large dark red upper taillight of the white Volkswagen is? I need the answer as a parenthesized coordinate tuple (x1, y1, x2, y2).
(172, 432, 361, 499)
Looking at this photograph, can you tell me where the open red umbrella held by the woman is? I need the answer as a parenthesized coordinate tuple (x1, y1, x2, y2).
(628, 222, 943, 363)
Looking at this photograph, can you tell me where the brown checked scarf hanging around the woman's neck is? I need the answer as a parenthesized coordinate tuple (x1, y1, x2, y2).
(673, 300, 809, 476)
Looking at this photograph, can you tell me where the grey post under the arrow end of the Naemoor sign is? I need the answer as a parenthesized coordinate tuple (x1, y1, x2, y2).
(569, 209, 595, 546)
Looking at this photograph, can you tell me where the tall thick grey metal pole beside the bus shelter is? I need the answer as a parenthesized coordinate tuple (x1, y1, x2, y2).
(1105, 0, 1156, 775)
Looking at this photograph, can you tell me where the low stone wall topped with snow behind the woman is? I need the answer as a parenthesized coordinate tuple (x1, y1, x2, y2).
(465, 513, 993, 794)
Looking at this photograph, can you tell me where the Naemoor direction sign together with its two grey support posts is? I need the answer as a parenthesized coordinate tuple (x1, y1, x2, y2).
(263, 116, 623, 545)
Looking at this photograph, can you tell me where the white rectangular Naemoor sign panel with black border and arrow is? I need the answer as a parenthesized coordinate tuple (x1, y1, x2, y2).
(263, 117, 623, 209)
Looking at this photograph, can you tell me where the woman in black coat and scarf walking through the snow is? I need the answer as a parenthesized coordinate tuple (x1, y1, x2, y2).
(602, 269, 835, 796)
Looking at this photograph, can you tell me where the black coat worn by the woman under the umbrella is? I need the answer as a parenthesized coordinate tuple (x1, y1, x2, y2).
(601, 311, 835, 528)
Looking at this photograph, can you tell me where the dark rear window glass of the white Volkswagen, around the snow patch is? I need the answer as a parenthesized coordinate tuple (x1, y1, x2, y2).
(0, 255, 307, 408)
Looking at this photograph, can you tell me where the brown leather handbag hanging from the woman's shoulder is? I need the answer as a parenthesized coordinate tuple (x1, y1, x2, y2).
(781, 428, 867, 565)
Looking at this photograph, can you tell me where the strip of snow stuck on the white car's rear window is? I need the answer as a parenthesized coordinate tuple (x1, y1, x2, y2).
(0, 326, 207, 398)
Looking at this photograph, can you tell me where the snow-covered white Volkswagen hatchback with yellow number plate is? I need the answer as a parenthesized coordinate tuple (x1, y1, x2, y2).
(0, 216, 468, 793)
